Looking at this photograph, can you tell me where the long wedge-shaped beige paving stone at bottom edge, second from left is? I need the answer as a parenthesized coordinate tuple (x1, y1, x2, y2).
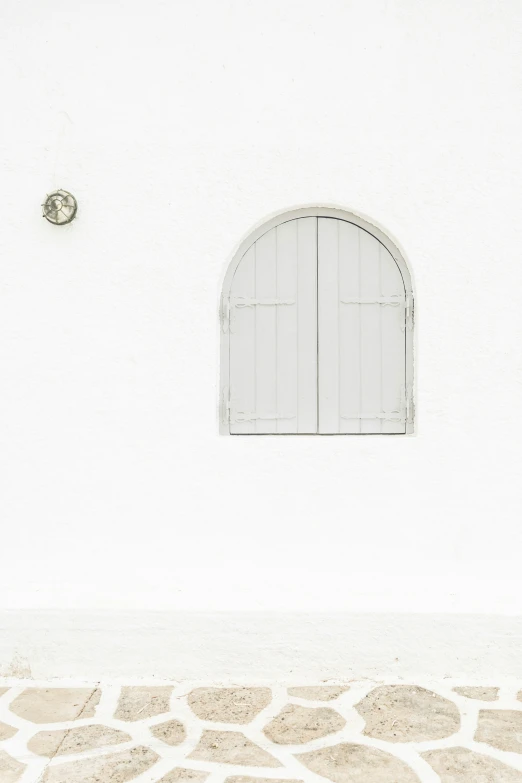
(42, 746, 159, 783)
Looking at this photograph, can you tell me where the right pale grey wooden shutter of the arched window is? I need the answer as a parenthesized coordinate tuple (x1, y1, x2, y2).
(318, 218, 409, 434)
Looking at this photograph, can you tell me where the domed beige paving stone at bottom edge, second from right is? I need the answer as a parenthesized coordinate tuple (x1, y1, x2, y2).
(296, 742, 418, 783)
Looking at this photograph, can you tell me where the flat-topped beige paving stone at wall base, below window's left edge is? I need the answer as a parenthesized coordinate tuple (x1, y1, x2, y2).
(188, 688, 272, 723)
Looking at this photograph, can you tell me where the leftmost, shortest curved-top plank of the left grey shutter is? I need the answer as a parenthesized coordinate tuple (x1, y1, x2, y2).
(230, 245, 256, 435)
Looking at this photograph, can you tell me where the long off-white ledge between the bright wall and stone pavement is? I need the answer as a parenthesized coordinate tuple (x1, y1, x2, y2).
(0, 610, 522, 682)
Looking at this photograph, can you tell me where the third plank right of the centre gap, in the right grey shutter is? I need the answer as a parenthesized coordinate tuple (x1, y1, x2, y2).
(360, 229, 382, 433)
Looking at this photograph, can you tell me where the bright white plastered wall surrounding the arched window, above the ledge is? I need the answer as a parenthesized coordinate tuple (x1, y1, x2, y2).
(0, 0, 522, 676)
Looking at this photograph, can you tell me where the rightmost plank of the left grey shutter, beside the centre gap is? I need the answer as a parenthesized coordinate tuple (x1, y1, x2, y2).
(296, 217, 317, 433)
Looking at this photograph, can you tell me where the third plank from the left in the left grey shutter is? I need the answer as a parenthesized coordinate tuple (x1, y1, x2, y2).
(274, 220, 298, 433)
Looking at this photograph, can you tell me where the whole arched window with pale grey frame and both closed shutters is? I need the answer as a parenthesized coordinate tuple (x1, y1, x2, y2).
(217, 208, 413, 435)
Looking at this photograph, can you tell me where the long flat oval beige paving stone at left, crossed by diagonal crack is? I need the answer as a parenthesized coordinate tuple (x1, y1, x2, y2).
(27, 726, 132, 758)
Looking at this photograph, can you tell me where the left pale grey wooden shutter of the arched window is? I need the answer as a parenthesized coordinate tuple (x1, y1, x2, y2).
(229, 217, 317, 435)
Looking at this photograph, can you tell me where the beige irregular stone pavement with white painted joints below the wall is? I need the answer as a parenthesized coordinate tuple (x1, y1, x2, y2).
(0, 680, 522, 783)
